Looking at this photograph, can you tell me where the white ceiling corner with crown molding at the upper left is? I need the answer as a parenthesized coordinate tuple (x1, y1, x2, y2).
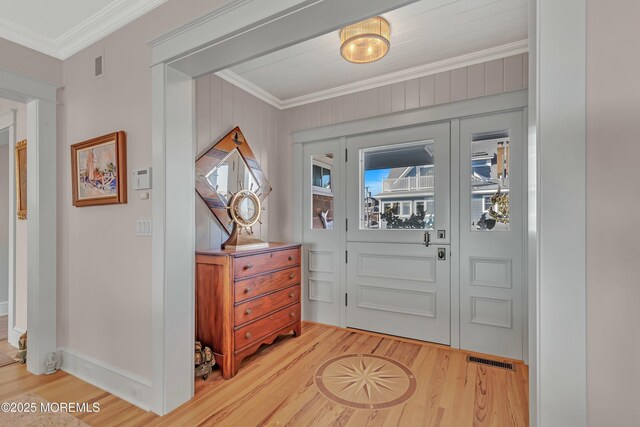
(0, 0, 167, 59)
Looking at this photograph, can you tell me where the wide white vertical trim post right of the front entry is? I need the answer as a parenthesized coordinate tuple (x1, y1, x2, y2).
(530, 0, 588, 427)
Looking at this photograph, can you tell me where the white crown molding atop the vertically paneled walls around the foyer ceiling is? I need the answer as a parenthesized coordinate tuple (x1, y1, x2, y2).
(216, 40, 529, 110)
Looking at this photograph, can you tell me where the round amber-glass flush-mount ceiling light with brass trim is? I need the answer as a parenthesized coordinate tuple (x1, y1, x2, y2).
(340, 16, 391, 64)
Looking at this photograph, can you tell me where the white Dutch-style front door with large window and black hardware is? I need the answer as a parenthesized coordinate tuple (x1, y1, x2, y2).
(345, 122, 451, 344)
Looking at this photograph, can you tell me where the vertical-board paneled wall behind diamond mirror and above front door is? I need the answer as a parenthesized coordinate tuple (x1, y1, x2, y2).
(196, 54, 528, 248)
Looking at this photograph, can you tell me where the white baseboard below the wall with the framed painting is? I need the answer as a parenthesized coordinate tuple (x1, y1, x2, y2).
(58, 347, 152, 411)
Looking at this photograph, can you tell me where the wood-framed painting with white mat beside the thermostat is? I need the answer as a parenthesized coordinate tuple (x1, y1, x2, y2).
(71, 131, 127, 207)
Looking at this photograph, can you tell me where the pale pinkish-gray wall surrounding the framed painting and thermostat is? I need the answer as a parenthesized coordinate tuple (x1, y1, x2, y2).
(57, 0, 228, 379)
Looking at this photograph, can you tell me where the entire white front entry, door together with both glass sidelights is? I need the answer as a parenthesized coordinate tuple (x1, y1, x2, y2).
(294, 105, 527, 361)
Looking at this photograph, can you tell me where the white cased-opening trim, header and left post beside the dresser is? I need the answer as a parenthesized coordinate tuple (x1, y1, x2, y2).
(151, 0, 424, 415)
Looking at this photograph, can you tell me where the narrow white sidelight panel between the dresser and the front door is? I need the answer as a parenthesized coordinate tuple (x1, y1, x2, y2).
(302, 139, 345, 325)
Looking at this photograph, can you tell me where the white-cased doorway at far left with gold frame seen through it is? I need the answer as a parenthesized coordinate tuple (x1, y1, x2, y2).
(0, 68, 57, 374)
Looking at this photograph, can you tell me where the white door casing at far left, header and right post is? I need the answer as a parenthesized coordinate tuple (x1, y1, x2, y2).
(0, 68, 57, 374)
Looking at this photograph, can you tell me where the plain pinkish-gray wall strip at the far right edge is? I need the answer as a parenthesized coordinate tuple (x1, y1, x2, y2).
(588, 0, 640, 427)
